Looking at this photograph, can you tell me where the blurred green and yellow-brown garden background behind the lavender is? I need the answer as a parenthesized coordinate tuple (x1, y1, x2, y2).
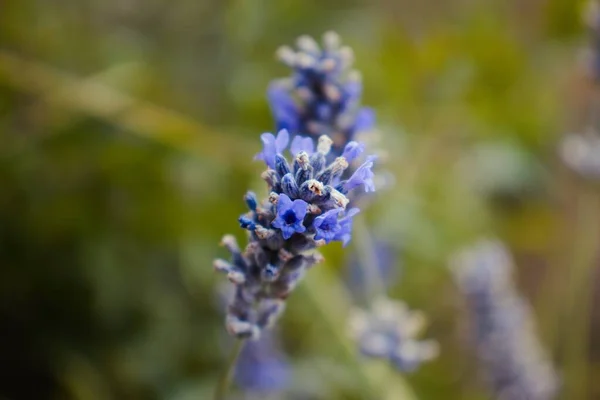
(0, 0, 600, 400)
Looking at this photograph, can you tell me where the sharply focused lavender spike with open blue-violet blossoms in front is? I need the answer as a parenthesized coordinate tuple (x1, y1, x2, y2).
(214, 130, 375, 338)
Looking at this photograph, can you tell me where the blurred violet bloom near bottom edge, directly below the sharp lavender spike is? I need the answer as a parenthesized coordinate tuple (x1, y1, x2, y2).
(235, 331, 291, 394)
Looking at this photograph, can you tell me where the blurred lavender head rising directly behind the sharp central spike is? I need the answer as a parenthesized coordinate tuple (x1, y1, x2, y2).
(268, 32, 375, 158)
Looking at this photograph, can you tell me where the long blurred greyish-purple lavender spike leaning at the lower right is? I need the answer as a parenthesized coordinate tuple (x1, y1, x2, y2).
(451, 240, 558, 400)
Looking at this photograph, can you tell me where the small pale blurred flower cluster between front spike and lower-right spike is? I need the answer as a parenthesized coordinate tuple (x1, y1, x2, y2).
(350, 298, 439, 372)
